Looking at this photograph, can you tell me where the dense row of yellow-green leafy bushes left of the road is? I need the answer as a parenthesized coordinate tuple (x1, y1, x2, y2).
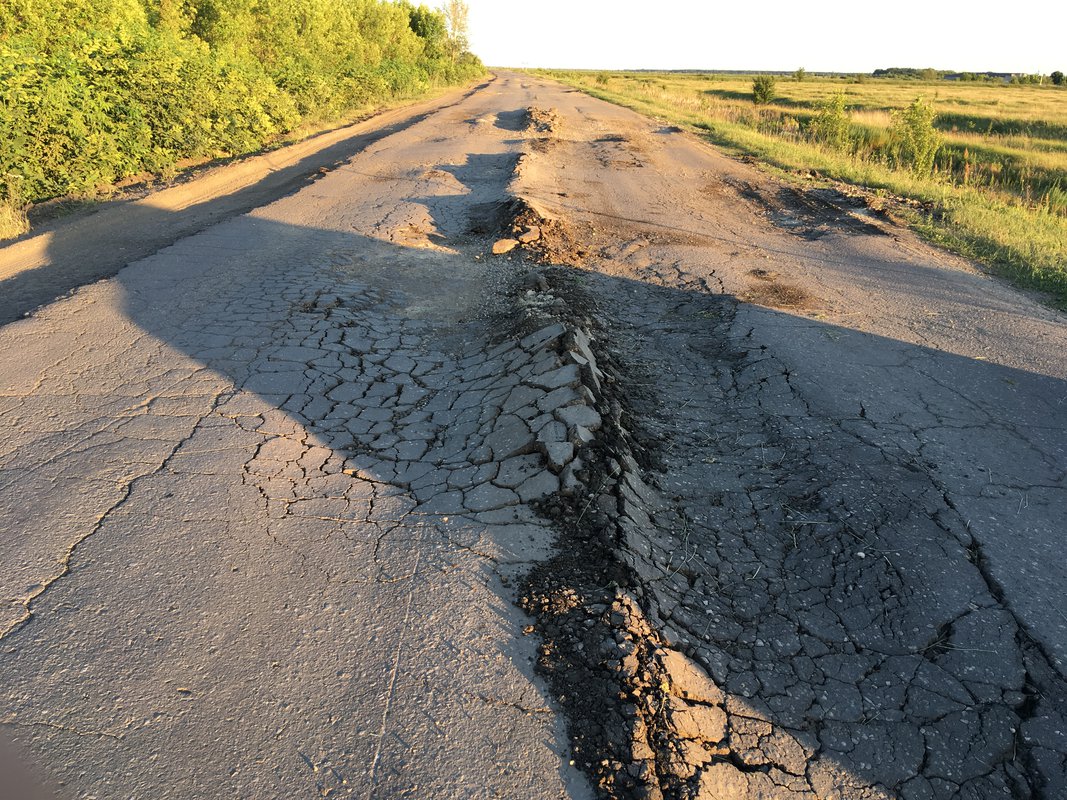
(0, 0, 484, 239)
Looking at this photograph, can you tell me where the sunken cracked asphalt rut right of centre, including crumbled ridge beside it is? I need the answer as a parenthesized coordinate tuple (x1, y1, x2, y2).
(503, 153, 1067, 800)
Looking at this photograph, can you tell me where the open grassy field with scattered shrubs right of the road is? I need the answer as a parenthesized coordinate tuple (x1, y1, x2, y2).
(538, 70, 1067, 308)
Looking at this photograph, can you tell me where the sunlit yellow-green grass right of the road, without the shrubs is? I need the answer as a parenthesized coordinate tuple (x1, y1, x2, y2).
(538, 70, 1067, 308)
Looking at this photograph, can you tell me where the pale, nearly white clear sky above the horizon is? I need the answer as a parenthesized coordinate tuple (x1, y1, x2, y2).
(468, 0, 1067, 75)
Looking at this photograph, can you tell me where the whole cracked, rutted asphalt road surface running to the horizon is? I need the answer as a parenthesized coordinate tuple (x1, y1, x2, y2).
(0, 75, 1067, 800)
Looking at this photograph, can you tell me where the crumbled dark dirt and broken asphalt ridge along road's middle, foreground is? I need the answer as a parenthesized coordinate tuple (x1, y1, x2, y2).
(510, 270, 727, 800)
